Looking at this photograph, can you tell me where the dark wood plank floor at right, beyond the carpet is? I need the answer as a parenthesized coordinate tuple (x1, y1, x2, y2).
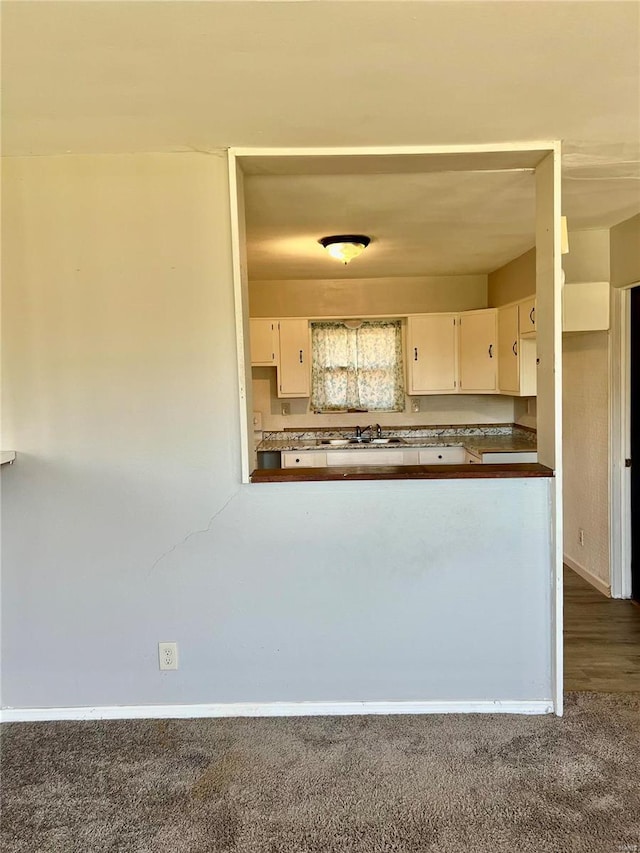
(564, 566, 640, 693)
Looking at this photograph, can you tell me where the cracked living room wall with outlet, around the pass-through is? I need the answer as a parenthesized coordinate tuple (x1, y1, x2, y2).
(0, 152, 552, 709)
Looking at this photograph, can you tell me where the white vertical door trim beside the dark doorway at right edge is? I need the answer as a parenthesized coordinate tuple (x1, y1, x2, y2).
(609, 285, 633, 598)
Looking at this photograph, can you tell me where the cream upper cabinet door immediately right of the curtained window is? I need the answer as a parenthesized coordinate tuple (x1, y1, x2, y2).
(407, 314, 458, 394)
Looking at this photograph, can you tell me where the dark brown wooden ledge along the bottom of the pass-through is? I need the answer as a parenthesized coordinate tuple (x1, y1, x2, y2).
(251, 462, 553, 483)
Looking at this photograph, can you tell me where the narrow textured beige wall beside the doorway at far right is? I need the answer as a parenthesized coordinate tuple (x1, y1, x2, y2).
(563, 332, 610, 588)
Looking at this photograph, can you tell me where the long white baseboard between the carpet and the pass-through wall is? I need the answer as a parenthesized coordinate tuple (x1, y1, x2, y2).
(0, 699, 554, 723)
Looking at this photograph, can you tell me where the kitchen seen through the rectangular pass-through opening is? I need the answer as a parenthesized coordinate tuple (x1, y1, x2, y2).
(245, 158, 537, 476)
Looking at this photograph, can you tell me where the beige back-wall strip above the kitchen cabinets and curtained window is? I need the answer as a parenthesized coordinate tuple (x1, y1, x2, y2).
(249, 275, 487, 317)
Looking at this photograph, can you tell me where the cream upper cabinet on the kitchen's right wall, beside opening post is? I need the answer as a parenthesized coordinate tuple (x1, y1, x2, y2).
(498, 300, 537, 397)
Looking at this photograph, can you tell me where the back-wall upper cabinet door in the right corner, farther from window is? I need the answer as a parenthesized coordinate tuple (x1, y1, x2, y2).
(458, 308, 498, 394)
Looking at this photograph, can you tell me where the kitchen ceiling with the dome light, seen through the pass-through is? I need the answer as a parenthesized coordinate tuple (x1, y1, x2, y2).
(245, 171, 535, 279)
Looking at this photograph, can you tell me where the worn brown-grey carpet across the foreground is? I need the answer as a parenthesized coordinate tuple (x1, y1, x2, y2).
(1, 693, 640, 853)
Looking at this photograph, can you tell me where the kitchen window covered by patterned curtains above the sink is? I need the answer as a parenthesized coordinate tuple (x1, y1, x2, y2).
(311, 320, 405, 412)
